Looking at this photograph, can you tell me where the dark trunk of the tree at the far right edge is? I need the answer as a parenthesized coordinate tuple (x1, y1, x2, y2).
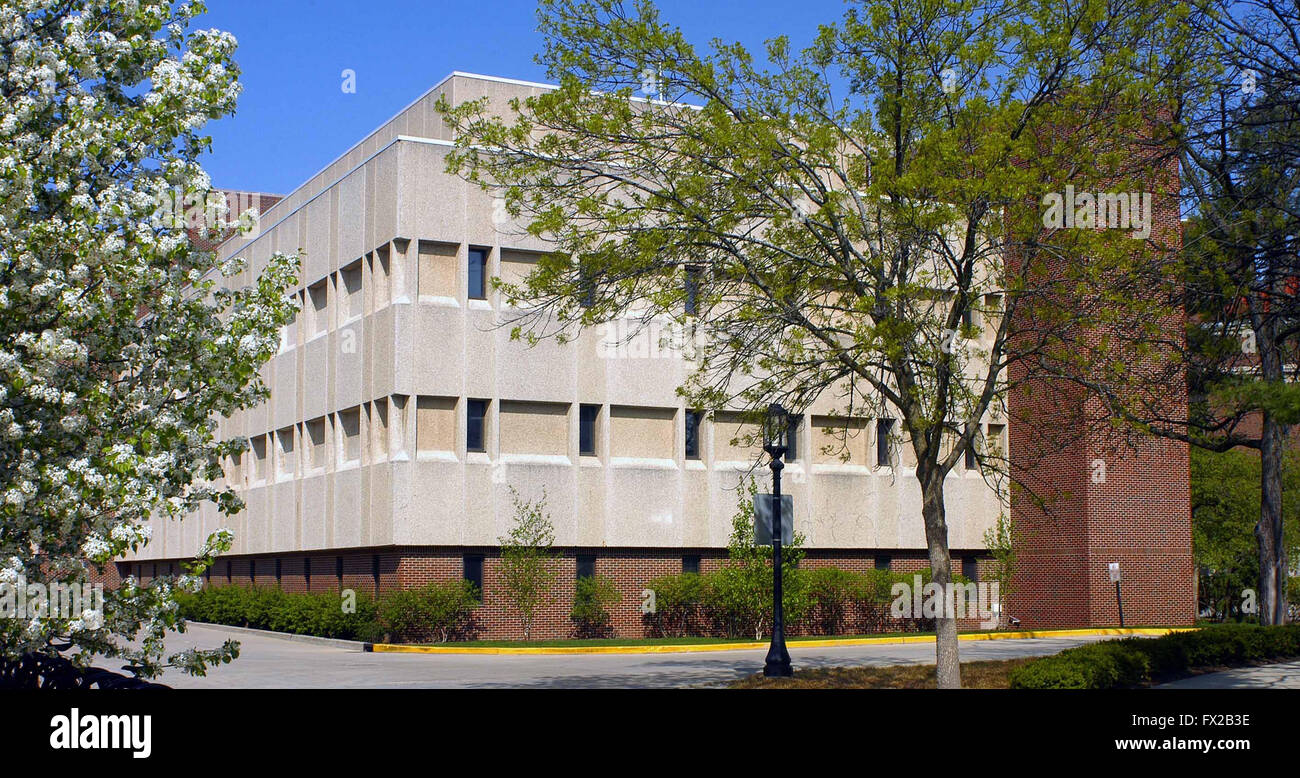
(1255, 411, 1287, 624)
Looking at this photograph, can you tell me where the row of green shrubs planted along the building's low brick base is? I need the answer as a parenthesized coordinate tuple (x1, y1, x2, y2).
(181, 562, 982, 643)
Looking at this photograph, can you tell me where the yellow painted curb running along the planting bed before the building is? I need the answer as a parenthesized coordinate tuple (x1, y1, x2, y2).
(371, 627, 1195, 656)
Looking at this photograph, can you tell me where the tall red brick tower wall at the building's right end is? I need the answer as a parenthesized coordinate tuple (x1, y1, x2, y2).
(1008, 138, 1196, 627)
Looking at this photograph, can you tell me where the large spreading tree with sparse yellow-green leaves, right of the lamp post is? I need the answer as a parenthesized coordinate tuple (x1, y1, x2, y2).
(439, 0, 1179, 687)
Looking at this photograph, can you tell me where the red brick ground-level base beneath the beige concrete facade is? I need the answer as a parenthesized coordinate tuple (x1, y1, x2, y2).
(109, 546, 991, 640)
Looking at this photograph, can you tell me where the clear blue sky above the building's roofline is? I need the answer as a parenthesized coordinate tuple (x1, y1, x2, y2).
(198, 0, 845, 194)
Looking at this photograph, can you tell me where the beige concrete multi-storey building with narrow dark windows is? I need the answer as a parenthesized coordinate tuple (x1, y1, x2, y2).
(122, 73, 1191, 636)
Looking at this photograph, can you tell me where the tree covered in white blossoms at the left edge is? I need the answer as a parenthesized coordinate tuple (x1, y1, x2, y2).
(0, 0, 298, 678)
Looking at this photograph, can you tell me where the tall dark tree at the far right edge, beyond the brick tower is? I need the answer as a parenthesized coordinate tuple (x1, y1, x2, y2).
(1086, 0, 1300, 623)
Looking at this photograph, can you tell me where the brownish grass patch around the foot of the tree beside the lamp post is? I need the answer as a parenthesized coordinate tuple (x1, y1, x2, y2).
(731, 657, 1035, 688)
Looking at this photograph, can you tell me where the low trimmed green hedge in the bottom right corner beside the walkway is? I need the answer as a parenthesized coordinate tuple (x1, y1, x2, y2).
(1010, 624, 1300, 688)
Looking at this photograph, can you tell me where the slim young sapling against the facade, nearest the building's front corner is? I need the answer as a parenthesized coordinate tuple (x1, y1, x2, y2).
(497, 487, 559, 640)
